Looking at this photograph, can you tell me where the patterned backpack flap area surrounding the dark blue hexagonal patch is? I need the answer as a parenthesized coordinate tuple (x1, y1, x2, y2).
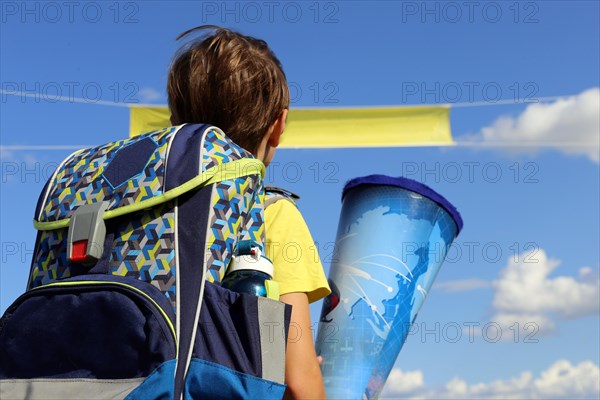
(36, 127, 175, 221)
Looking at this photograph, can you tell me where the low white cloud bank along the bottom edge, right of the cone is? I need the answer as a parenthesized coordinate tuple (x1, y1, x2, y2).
(381, 360, 600, 399)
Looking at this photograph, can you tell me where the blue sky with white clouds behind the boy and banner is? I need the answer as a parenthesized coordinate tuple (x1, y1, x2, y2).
(0, 1, 600, 398)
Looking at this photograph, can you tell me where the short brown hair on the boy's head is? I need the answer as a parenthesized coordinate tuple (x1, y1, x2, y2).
(167, 25, 290, 152)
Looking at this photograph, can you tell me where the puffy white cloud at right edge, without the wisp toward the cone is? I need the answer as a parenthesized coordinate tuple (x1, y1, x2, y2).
(493, 249, 600, 323)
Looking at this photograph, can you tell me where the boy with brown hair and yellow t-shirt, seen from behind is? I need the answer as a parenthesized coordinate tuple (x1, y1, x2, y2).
(167, 26, 330, 398)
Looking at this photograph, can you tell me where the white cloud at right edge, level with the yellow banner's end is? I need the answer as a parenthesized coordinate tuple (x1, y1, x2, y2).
(465, 88, 600, 163)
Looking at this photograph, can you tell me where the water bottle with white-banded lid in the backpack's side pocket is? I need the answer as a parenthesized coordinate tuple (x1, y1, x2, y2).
(221, 241, 273, 297)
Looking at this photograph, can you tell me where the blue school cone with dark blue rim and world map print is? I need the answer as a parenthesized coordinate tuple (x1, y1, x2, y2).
(316, 175, 463, 399)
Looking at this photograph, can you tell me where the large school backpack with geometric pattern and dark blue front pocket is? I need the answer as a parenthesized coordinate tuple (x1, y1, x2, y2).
(0, 124, 291, 399)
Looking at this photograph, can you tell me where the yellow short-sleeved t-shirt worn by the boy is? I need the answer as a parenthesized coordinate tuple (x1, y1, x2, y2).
(265, 199, 331, 303)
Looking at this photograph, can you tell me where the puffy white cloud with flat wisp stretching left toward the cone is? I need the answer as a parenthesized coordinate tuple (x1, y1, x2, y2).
(435, 248, 600, 340)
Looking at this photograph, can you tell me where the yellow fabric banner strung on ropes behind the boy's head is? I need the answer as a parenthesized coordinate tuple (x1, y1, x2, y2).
(129, 106, 454, 148)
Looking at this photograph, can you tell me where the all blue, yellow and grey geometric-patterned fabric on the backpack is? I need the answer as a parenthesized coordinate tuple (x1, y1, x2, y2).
(30, 127, 265, 294)
